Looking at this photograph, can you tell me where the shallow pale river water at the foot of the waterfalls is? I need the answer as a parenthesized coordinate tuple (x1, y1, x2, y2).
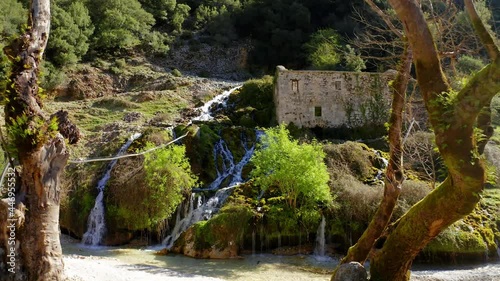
(62, 236, 500, 281)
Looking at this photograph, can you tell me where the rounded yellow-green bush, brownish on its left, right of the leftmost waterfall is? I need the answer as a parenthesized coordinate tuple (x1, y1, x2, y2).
(107, 143, 197, 230)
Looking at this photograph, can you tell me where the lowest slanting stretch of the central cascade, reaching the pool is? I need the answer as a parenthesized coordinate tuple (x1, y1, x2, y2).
(162, 186, 234, 249)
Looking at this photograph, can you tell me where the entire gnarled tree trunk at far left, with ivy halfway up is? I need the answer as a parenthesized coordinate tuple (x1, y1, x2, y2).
(0, 0, 79, 281)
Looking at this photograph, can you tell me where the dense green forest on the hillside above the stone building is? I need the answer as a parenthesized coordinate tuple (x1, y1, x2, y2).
(0, 0, 500, 88)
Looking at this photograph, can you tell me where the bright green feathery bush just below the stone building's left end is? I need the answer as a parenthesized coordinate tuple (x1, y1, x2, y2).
(251, 125, 332, 208)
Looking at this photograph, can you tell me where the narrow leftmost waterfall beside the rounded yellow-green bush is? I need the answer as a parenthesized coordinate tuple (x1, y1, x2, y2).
(82, 133, 141, 246)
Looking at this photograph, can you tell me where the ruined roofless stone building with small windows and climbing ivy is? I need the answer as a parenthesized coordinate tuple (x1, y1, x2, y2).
(274, 66, 395, 128)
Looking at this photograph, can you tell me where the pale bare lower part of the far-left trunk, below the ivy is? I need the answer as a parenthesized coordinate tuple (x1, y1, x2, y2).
(20, 135, 69, 281)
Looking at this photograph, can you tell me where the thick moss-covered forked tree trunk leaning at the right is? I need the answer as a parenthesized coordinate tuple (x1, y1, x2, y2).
(370, 0, 500, 281)
